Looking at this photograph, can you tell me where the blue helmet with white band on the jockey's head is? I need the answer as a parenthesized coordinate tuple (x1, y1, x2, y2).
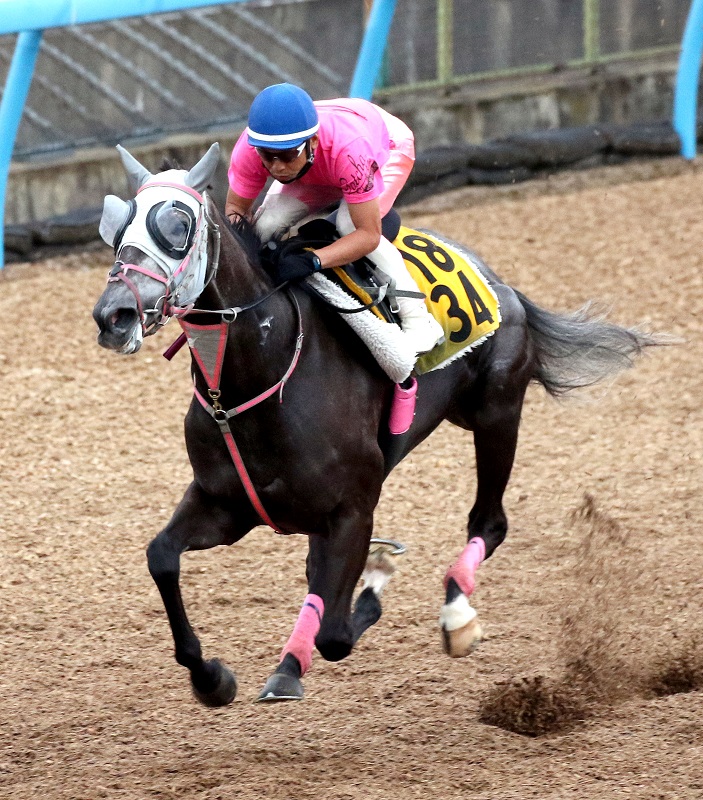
(247, 83, 320, 150)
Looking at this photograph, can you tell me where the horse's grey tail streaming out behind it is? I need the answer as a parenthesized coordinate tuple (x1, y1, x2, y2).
(515, 290, 665, 397)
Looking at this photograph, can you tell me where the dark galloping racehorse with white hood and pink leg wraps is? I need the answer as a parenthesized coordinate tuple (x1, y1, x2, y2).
(93, 143, 657, 706)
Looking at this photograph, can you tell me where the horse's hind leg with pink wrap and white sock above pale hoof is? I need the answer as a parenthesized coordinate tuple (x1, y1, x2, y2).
(440, 352, 528, 658)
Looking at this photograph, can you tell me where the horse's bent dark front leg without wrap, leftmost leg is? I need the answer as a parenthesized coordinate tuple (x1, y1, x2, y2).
(147, 483, 255, 706)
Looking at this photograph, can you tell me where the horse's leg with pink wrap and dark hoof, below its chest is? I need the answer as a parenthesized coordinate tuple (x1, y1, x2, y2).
(258, 510, 380, 700)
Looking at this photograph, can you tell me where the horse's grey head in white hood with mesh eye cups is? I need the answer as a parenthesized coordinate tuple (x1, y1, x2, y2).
(93, 143, 219, 353)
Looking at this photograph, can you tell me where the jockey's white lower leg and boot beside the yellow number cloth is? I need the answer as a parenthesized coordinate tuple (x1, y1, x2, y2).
(337, 203, 444, 355)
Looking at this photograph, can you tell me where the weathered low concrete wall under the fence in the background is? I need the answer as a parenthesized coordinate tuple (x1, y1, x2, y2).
(6, 51, 677, 224)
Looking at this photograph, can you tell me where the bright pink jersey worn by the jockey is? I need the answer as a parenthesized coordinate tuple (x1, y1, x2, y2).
(228, 98, 393, 203)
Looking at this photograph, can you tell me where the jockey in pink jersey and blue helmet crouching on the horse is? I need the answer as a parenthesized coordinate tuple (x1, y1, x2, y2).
(225, 83, 443, 354)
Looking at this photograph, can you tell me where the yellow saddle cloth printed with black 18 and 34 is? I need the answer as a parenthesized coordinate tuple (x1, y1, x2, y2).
(393, 227, 501, 375)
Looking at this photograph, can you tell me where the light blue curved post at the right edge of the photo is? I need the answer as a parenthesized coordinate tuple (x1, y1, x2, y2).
(674, 0, 703, 159)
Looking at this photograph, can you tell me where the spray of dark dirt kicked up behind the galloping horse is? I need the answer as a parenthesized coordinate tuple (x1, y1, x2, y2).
(479, 495, 703, 736)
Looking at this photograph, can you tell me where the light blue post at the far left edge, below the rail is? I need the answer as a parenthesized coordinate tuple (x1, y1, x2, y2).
(0, 31, 43, 270)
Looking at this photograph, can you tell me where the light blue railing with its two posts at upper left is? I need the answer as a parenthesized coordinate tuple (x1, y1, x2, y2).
(0, 0, 396, 270)
